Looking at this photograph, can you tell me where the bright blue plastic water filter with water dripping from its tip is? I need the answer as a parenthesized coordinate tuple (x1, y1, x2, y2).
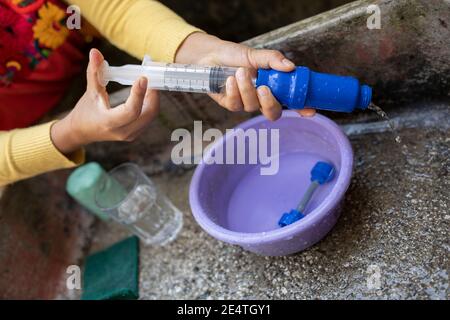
(256, 67, 372, 112)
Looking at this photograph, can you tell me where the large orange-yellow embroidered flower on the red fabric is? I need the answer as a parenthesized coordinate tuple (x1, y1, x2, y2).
(33, 2, 69, 49)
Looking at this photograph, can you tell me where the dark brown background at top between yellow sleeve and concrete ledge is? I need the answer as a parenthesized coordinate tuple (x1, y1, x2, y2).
(161, 0, 351, 42)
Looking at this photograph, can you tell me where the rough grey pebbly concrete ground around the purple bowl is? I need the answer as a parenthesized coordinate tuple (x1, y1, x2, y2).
(92, 104, 450, 299)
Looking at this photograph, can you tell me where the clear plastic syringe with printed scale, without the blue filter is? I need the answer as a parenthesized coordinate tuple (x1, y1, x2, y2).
(100, 61, 237, 93)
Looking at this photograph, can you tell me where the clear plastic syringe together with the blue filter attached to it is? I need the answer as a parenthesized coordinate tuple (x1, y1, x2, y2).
(100, 57, 372, 112)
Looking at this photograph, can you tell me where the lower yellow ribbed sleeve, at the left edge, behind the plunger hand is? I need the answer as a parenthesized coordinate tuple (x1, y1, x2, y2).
(0, 121, 85, 187)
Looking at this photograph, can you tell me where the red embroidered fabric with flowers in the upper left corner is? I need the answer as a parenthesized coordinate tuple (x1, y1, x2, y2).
(0, 0, 85, 130)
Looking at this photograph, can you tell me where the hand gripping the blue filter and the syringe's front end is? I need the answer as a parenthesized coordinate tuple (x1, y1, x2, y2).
(175, 32, 315, 120)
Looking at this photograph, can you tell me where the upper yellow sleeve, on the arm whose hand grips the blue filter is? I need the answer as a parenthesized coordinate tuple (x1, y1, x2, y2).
(67, 0, 202, 62)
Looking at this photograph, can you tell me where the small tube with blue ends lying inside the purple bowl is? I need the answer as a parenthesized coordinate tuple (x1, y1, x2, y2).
(278, 161, 336, 228)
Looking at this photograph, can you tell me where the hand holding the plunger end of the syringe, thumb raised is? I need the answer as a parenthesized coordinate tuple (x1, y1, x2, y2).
(51, 49, 159, 154)
